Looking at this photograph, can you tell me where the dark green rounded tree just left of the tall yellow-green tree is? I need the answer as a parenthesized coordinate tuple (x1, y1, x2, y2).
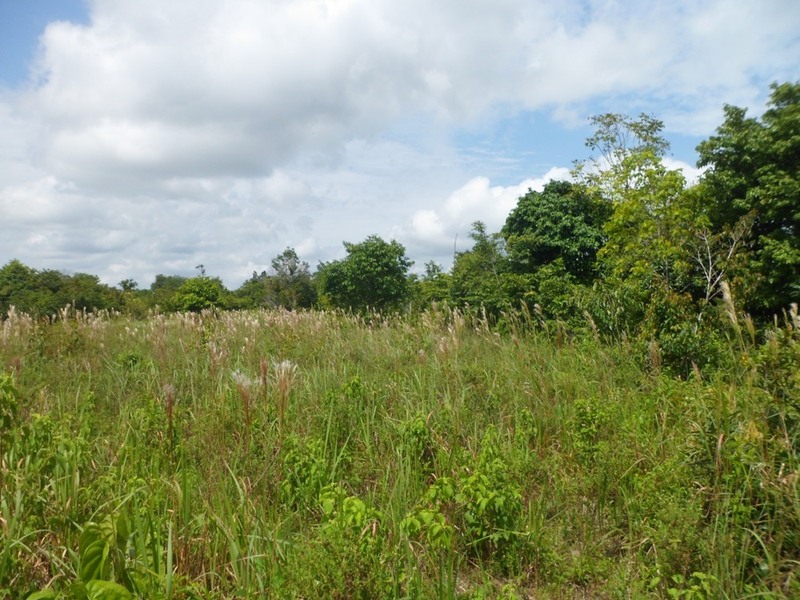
(501, 181, 611, 282)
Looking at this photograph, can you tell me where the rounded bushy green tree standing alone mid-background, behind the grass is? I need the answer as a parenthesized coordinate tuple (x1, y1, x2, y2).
(318, 235, 413, 310)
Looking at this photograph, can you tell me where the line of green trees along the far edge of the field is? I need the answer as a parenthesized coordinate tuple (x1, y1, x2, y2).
(0, 82, 800, 365)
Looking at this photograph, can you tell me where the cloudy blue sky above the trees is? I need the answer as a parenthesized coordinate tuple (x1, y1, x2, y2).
(0, 0, 800, 288)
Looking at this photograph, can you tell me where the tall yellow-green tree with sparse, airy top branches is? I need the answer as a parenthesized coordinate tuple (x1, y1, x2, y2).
(585, 115, 711, 372)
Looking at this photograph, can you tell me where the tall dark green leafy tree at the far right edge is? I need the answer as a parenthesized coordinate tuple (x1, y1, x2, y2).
(697, 82, 800, 317)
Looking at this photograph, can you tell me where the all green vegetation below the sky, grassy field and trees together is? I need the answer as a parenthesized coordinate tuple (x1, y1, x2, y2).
(0, 83, 800, 600)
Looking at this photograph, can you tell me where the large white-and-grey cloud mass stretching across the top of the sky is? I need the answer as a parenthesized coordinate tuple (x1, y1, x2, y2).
(25, 0, 797, 188)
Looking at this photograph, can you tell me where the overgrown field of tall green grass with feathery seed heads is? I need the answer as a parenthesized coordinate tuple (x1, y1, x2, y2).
(0, 311, 800, 598)
